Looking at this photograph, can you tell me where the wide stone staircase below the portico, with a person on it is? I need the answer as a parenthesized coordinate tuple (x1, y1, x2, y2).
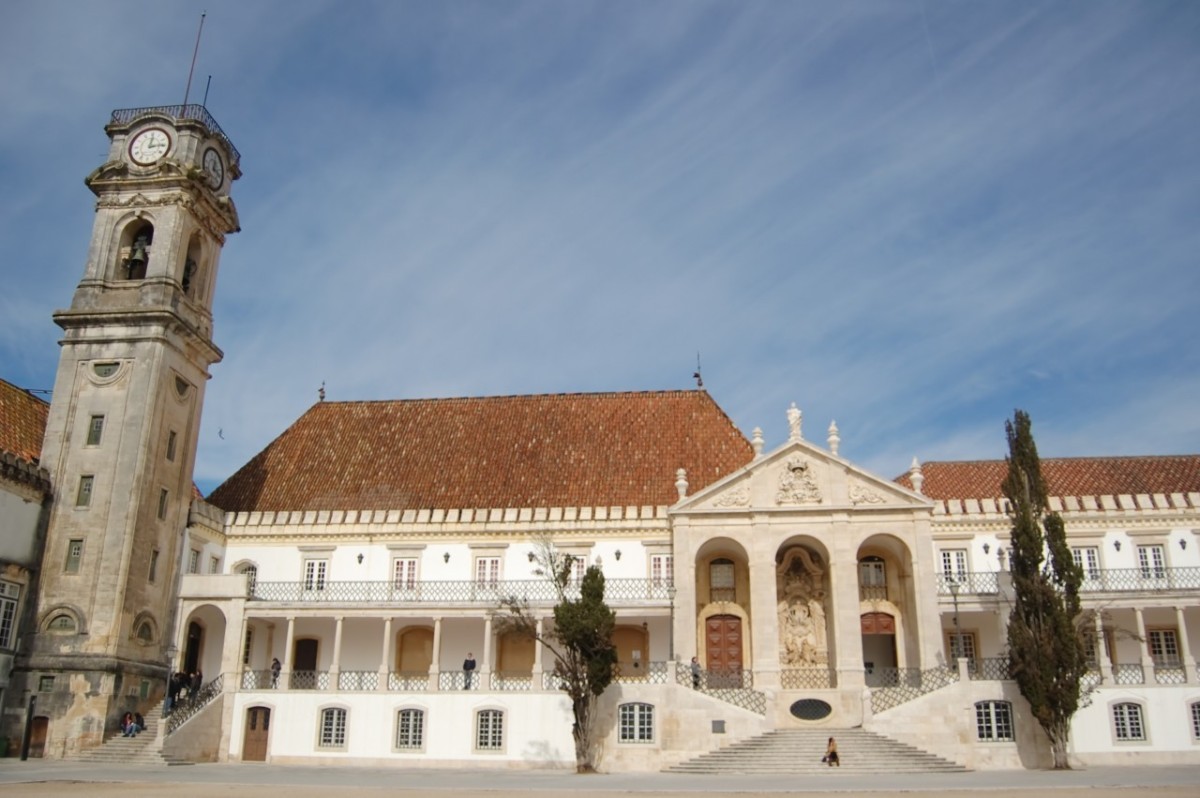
(666, 728, 966, 774)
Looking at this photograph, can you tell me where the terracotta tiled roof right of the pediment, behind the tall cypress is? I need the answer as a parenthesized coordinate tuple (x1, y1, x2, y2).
(896, 455, 1200, 499)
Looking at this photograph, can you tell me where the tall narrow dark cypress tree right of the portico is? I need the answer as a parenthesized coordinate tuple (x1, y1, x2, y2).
(1003, 410, 1087, 769)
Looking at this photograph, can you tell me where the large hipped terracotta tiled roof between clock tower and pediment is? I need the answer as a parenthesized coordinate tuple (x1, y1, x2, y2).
(209, 391, 754, 511)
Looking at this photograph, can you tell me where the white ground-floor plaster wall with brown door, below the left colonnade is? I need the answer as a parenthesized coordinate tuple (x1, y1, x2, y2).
(229, 691, 575, 768)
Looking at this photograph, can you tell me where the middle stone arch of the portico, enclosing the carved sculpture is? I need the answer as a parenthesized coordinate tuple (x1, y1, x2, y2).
(775, 535, 836, 670)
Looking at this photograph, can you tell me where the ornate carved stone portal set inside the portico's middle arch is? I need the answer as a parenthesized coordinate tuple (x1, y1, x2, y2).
(775, 546, 829, 667)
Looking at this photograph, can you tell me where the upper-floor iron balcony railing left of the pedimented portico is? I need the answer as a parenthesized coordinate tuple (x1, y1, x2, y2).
(248, 578, 672, 605)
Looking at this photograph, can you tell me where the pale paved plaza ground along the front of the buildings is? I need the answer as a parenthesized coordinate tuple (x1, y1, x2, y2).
(0, 758, 1200, 798)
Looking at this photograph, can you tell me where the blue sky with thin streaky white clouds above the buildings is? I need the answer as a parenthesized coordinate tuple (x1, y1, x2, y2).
(0, 0, 1200, 490)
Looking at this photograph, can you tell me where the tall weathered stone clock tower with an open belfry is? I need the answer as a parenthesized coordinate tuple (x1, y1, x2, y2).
(13, 104, 241, 756)
